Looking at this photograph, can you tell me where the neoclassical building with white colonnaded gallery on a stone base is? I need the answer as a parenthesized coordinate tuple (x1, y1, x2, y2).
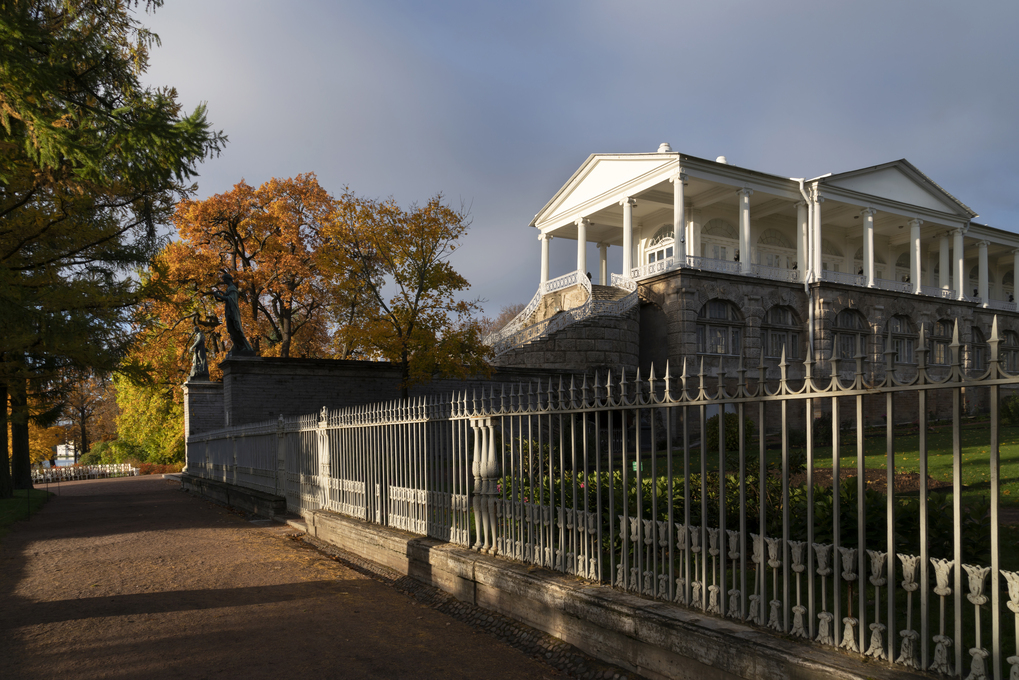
(489, 144, 1019, 417)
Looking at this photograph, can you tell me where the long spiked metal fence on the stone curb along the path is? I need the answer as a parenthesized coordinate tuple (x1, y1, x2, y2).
(187, 320, 1019, 680)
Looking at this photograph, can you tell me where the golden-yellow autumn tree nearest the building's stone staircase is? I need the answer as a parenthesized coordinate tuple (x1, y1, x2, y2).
(323, 191, 490, 398)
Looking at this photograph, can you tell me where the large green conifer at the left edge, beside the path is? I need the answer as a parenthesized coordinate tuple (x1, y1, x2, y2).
(0, 0, 225, 498)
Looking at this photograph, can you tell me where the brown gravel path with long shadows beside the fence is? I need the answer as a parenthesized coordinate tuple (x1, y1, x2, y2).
(0, 477, 621, 680)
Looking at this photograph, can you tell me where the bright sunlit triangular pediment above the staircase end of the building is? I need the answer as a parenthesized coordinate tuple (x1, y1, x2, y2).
(534, 154, 677, 226)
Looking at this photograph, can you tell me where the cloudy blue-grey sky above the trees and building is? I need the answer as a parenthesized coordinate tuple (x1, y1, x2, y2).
(139, 0, 1019, 317)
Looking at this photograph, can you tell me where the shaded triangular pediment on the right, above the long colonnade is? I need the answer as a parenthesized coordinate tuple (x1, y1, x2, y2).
(823, 160, 975, 217)
